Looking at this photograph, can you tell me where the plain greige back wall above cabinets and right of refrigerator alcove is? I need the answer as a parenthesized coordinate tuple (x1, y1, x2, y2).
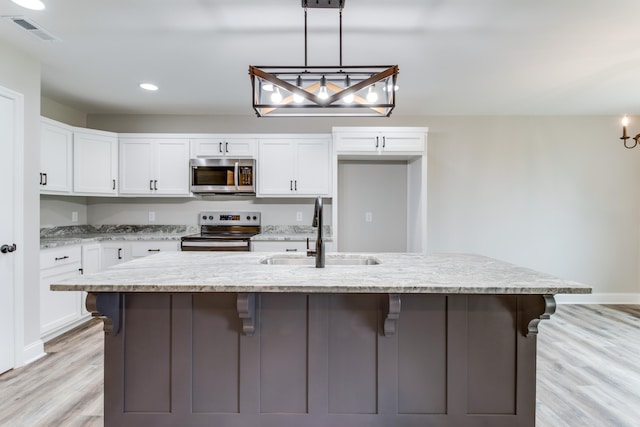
(82, 115, 640, 300)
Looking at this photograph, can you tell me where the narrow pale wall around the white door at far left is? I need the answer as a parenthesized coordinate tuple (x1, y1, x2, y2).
(0, 41, 42, 363)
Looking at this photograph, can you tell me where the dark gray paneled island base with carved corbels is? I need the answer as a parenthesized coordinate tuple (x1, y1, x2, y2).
(87, 291, 555, 427)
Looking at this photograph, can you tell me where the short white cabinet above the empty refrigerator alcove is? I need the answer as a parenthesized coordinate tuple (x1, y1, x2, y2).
(333, 127, 427, 156)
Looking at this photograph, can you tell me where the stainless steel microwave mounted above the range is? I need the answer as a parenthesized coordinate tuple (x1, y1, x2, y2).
(189, 158, 256, 195)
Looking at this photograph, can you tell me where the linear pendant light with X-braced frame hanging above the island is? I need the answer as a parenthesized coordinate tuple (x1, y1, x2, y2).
(249, 0, 398, 117)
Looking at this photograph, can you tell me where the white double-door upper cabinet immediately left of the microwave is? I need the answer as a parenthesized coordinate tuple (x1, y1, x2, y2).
(120, 137, 190, 196)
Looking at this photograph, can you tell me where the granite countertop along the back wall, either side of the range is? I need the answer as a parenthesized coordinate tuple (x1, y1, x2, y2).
(40, 225, 332, 249)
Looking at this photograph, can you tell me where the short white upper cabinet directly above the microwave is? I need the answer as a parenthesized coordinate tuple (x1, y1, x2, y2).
(191, 135, 258, 159)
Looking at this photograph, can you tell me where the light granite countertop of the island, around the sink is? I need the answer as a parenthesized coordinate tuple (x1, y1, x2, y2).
(51, 252, 591, 294)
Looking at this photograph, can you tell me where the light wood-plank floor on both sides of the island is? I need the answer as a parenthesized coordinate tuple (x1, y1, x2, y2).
(0, 305, 640, 427)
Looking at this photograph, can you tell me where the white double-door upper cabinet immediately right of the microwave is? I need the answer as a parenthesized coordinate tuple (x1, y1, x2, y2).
(257, 135, 331, 197)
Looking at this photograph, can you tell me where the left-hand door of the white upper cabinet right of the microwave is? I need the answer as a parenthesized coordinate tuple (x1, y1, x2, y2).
(258, 139, 295, 196)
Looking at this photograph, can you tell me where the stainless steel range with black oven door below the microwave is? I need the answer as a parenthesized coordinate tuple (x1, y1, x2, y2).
(180, 212, 260, 252)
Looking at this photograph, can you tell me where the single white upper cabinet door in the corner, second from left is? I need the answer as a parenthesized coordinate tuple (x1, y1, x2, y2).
(73, 132, 118, 195)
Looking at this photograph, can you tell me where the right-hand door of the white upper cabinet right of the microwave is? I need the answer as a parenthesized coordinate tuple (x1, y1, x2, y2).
(295, 139, 331, 196)
